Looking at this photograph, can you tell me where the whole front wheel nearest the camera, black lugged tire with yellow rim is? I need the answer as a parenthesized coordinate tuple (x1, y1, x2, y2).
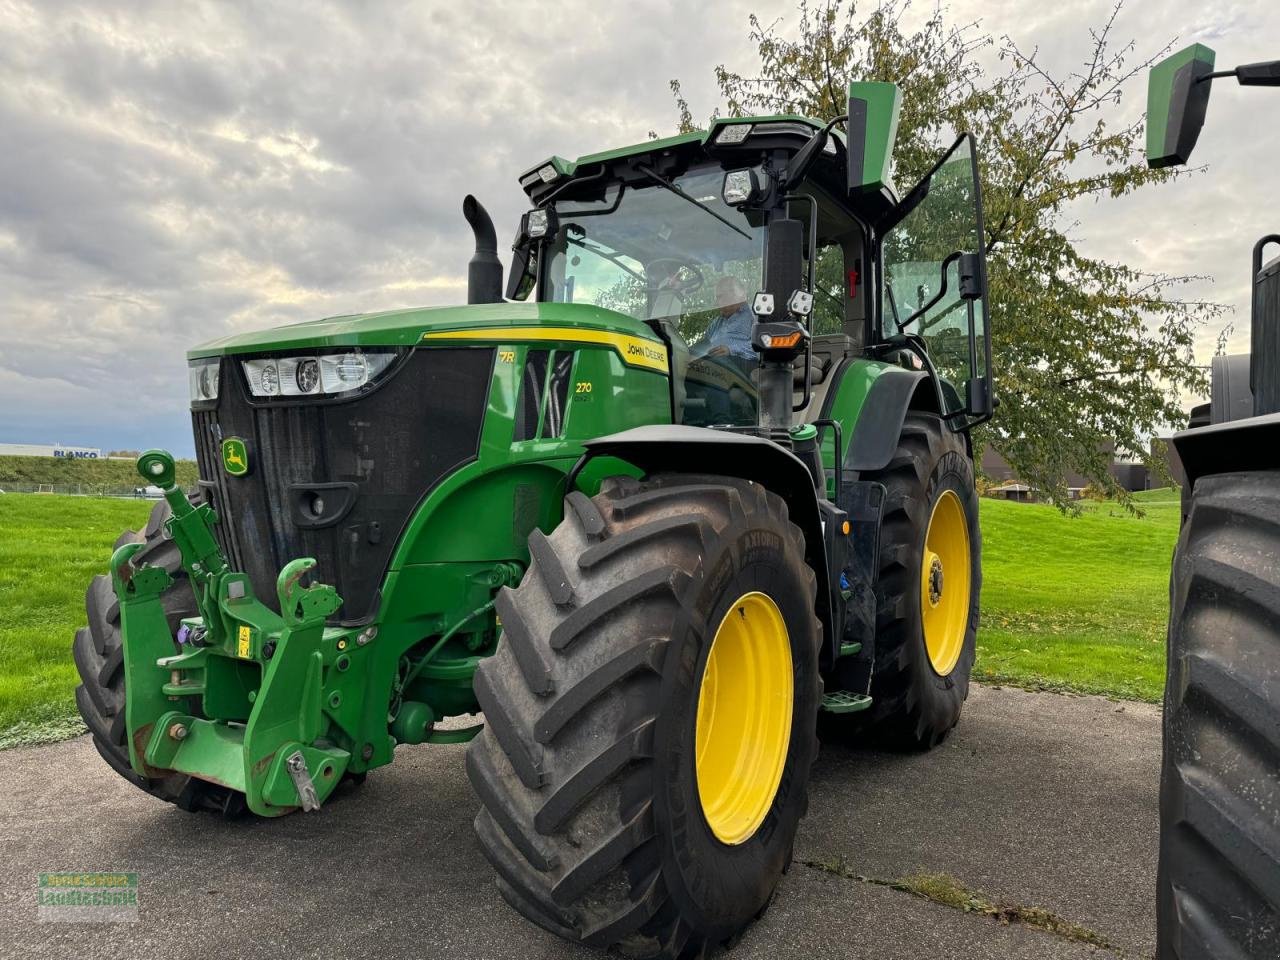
(467, 476, 820, 957)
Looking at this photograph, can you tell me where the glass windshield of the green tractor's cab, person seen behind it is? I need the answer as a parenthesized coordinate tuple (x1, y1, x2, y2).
(541, 165, 765, 425)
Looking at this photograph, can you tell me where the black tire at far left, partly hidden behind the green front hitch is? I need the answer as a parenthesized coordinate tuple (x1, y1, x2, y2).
(72, 500, 244, 817)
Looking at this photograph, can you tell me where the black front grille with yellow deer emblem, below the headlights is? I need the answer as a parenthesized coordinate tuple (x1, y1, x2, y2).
(192, 348, 493, 625)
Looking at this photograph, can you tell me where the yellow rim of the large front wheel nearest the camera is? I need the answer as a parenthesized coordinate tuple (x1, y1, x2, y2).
(695, 591, 794, 844)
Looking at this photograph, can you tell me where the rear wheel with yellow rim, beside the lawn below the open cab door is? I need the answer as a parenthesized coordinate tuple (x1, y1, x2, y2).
(839, 412, 982, 750)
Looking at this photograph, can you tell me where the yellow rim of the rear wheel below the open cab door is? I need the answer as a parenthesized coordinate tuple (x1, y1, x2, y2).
(920, 490, 973, 677)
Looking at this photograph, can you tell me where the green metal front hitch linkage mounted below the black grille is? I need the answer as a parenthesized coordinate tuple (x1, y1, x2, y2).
(111, 451, 350, 817)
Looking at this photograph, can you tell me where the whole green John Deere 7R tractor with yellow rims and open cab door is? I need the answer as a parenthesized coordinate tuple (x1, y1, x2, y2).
(74, 83, 993, 956)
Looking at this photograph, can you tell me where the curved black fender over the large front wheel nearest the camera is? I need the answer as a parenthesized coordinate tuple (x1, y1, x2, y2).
(570, 424, 834, 670)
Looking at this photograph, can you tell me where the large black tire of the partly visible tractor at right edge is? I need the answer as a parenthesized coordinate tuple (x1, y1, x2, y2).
(1156, 471, 1280, 960)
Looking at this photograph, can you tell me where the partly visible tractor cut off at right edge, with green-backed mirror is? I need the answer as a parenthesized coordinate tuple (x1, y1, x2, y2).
(1147, 44, 1280, 960)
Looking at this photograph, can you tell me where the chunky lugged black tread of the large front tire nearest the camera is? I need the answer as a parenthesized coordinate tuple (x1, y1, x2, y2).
(467, 476, 819, 960)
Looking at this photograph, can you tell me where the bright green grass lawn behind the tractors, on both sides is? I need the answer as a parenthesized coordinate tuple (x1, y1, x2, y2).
(0, 490, 1178, 746)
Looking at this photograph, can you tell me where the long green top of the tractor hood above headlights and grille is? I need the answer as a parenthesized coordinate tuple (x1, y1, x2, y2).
(187, 303, 666, 360)
